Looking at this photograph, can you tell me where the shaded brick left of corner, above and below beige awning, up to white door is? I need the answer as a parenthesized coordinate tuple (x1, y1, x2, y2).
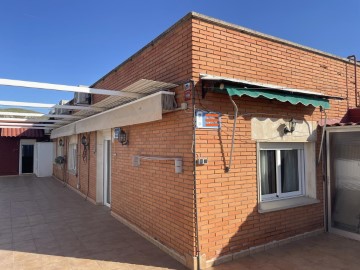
(89, 17, 194, 256)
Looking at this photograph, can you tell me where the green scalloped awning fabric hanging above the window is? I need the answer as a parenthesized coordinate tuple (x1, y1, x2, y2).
(226, 87, 330, 109)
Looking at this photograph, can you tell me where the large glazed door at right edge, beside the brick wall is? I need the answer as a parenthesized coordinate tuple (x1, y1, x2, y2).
(327, 128, 360, 240)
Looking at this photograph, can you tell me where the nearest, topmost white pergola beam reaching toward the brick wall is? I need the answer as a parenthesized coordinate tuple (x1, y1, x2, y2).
(0, 78, 144, 98)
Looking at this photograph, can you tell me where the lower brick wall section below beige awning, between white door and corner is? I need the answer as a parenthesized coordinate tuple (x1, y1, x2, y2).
(112, 112, 194, 256)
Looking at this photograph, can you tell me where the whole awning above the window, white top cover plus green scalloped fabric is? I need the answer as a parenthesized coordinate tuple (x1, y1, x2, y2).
(200, 74, 344, 109)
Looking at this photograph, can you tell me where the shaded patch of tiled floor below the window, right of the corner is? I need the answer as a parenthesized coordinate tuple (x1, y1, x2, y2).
(211, 233, 360, 270)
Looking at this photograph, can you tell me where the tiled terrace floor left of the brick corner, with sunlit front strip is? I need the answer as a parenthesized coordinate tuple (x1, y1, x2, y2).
(0, 176, 185, 270)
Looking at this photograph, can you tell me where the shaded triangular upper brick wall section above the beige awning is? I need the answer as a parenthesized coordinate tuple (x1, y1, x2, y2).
(93, 20, 191, 103)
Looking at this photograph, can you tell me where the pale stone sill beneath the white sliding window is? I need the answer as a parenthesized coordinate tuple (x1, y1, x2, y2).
(258, 196, 320, 213)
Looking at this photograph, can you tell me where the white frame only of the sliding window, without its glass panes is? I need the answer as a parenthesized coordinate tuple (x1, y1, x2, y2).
(258, 142, 306, 202)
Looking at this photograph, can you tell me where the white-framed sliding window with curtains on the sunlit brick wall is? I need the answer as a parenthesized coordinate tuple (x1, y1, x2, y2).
(259, 143, 305, 202)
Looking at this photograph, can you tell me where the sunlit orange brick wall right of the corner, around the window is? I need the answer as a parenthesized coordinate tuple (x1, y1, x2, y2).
(192, 15, 354, 259)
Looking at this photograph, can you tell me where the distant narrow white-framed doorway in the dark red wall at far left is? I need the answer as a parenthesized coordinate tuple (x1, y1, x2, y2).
(19, 140, 36, 174)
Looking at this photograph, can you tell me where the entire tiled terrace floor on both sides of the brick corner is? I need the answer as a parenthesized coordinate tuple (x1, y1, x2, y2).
(0, 176, 360, 270)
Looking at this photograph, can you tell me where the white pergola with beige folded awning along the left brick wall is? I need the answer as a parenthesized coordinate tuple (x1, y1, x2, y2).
(0, 79, 177, 134)
